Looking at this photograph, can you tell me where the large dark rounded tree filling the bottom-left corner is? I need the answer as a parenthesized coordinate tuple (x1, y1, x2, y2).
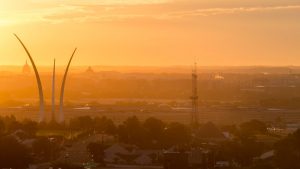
(0, 137, 31, 169)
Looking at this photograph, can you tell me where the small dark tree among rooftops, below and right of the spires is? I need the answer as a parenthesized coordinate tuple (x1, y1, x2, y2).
(87, 142, 105, 164)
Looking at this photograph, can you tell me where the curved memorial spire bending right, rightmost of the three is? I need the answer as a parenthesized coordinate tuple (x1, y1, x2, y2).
(59, 48, 77, 122)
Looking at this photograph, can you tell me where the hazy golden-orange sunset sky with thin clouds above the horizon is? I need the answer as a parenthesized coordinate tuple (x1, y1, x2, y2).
(0, 0, 300, 66)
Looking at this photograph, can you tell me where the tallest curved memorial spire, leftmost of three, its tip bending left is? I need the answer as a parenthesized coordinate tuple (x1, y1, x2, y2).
(14, 34, 45, 122)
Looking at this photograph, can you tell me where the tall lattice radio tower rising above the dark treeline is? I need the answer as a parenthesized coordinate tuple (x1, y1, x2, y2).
(191, 62, 198, 127)
